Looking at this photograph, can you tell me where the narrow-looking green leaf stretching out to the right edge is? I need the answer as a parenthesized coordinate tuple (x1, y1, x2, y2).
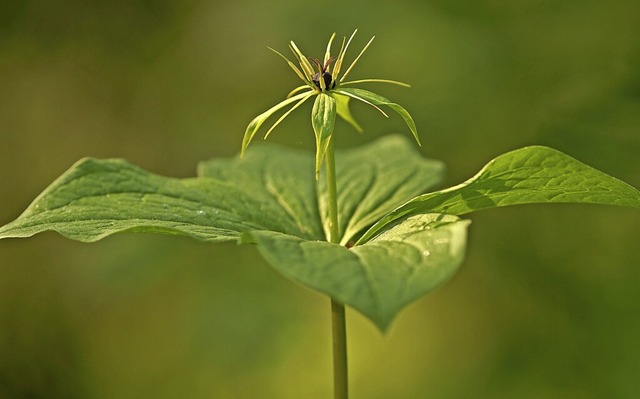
(360, 146, 640, 242)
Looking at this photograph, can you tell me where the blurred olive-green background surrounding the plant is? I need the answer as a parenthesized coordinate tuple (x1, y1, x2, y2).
(0, 0, 640, 399)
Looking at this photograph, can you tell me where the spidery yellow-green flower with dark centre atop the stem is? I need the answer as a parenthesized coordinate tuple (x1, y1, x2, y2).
(241, 29, 420, 177)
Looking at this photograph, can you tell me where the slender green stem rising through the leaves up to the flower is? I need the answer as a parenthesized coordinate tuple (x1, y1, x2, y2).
(325, 138, 349, 399)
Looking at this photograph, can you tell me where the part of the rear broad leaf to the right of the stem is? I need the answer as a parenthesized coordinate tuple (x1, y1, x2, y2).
(319, 135, 445, 245)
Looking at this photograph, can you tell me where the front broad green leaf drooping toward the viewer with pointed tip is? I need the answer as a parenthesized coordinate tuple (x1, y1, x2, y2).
(246, 214, 469, 331)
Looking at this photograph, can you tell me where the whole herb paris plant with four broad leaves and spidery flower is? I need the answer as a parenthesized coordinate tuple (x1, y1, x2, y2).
(0, 28, 640, 398)
